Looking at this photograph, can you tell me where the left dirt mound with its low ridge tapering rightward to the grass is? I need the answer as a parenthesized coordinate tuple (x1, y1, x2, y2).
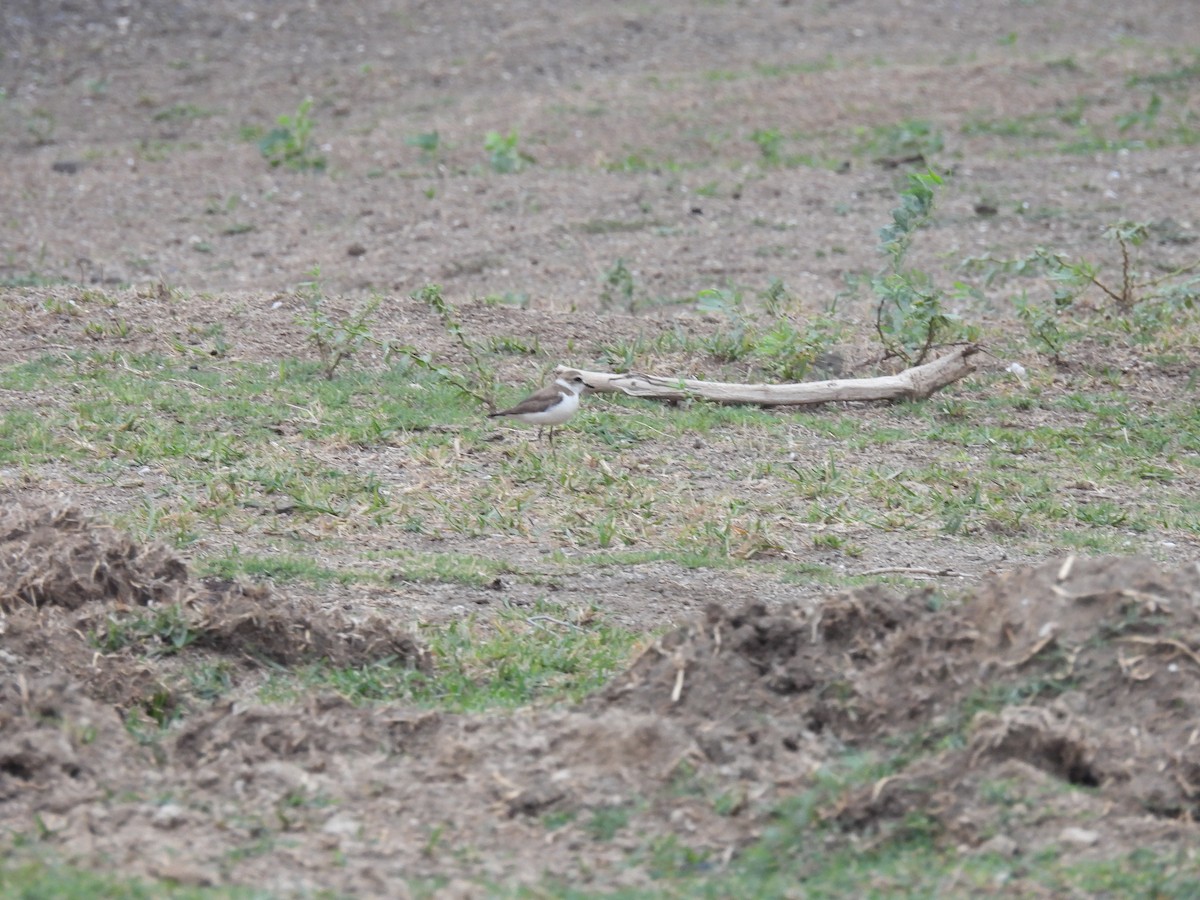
(0, 499, 427, 709)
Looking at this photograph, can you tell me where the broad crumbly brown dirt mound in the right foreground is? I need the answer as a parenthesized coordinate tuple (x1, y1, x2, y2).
(602, 557, 1200, 859)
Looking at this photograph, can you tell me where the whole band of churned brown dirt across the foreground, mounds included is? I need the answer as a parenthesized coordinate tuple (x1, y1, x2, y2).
(0, 506, 1200, 895)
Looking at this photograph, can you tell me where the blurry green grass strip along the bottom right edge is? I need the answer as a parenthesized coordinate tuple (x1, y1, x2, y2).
(532, 755, 1200, 900)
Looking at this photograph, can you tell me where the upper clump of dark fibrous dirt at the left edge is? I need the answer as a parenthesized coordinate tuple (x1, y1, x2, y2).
(0, 502, 187, 610)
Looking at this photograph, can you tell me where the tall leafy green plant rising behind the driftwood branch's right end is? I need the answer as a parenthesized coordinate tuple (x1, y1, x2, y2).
(870, 172, 973, 366)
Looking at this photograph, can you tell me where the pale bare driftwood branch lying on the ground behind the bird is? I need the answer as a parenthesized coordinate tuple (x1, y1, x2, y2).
(554, 344, 979, 407)
